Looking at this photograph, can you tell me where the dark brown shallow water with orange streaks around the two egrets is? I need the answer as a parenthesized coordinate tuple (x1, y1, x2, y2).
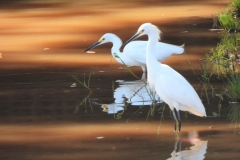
(0, 0, 240, 160)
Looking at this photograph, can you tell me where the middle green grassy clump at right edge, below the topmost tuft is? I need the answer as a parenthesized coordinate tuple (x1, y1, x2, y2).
(202, 32, 240, 77)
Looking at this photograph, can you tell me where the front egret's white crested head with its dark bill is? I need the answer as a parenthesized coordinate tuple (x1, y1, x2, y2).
(125, 23, 161, 45)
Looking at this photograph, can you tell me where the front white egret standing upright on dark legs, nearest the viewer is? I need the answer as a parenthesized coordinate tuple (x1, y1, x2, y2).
(126, 23, 206, 132)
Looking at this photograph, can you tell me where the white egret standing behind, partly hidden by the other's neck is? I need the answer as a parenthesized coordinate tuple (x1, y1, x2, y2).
(84, 33, 184, 76)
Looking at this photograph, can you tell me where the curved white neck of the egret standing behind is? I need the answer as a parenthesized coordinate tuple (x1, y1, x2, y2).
(111, 36, 122, 63)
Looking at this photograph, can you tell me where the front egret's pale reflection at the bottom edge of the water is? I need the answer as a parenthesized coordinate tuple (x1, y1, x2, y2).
(167, 131, 208, 160)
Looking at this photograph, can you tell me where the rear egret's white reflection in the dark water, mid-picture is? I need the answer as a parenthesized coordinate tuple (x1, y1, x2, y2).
(95, 80, 163, 114)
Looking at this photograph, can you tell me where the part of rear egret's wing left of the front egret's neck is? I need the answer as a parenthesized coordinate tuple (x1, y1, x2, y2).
(123, 41, 147, 64)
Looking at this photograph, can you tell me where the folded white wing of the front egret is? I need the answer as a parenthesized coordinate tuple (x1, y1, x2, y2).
(156, 67, 205, 116)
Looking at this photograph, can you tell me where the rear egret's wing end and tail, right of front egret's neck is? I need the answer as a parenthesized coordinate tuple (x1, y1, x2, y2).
(155, 42, 184, 61)
